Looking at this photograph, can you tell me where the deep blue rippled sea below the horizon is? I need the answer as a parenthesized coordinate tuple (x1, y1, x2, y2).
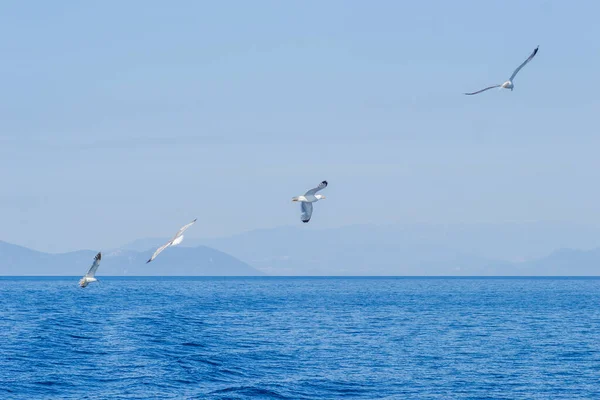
(0, 277, 600, 399)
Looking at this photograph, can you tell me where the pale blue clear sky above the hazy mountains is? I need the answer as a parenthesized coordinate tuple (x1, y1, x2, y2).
(0, 0, 600, 252)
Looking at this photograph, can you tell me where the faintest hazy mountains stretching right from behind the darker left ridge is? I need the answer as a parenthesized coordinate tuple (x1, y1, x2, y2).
(198, 222, 600, 275)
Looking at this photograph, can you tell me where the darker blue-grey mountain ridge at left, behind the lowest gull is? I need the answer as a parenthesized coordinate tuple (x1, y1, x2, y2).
(0, 242, 263, 276)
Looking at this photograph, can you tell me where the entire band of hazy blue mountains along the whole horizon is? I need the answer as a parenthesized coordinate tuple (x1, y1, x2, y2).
(0, 223, 600, 276)
